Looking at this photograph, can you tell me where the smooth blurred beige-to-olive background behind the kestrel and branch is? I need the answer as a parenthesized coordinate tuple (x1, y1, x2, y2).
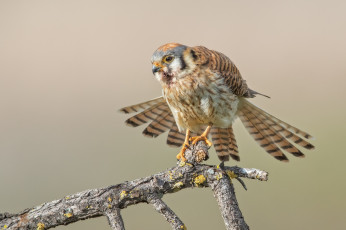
(0, 0, 346, 230)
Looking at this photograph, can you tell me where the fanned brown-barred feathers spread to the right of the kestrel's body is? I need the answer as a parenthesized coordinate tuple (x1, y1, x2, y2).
(237, 99, 314, 161)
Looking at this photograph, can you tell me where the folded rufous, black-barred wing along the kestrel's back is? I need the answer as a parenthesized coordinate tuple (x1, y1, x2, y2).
(191, 46, 259, 97)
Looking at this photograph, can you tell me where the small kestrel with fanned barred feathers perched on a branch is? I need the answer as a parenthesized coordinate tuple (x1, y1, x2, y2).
(120, 43, 314, 162)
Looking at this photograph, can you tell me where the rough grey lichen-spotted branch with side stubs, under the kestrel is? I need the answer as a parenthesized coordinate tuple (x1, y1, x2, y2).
(0, 142, 268, 230)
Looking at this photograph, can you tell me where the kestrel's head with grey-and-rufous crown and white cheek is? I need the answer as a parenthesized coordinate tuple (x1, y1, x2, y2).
(151, 43, 195, 85)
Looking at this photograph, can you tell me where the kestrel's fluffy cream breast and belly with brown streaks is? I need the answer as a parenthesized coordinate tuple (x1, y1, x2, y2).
(163, 71, 238, 132)
